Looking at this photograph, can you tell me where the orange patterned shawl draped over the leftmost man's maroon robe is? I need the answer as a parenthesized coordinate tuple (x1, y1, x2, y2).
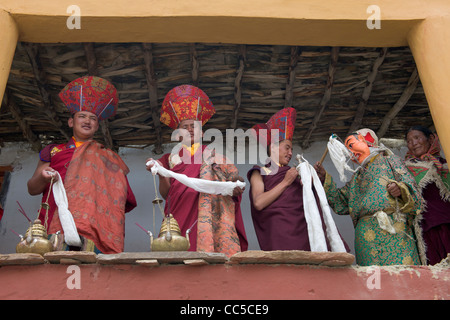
(49, 140, 129, 254)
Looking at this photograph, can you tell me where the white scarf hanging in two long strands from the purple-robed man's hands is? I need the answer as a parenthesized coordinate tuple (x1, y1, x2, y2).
(296, 155, 347, 252)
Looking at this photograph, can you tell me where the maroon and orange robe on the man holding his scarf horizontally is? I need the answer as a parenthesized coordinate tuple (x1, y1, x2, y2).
(159, 145, 248, 256)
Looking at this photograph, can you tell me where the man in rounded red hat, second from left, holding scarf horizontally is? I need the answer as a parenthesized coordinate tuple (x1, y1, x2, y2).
(147, 85, 248, 256)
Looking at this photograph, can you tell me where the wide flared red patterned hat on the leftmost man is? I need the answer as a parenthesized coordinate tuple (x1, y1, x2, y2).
(59, 76, 119, 121)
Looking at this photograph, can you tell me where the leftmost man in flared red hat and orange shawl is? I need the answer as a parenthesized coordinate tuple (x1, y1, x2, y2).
(28, 76, 136, 254)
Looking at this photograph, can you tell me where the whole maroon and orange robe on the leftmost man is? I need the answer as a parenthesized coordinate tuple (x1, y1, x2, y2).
(39, 139, 136, 254)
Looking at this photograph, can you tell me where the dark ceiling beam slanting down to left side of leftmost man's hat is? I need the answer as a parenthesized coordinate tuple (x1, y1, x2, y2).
(23, 43, 72, 140)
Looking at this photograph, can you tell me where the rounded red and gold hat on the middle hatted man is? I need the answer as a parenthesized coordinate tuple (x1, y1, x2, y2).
(160, 84, 216, 129)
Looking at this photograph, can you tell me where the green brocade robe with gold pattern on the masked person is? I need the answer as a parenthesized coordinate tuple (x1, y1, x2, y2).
(324, 152, 423, 265)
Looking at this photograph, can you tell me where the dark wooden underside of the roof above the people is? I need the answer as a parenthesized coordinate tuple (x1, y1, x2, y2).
(0, 43, 433, 152)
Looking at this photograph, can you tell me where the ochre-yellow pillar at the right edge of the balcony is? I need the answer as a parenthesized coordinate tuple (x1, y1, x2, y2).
(408, 15, 450, 159)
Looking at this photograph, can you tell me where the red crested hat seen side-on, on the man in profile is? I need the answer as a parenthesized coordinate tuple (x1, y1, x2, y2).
(253, 107, 297, 145)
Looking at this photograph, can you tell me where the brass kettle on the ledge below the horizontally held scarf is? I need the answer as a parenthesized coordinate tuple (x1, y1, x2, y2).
(150, 214, 190, 251)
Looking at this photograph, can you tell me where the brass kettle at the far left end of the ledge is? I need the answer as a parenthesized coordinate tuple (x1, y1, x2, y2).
(16, 219, 53, 256)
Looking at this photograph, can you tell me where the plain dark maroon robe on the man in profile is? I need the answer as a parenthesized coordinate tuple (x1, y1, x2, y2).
(247, 166, 350, 252)
